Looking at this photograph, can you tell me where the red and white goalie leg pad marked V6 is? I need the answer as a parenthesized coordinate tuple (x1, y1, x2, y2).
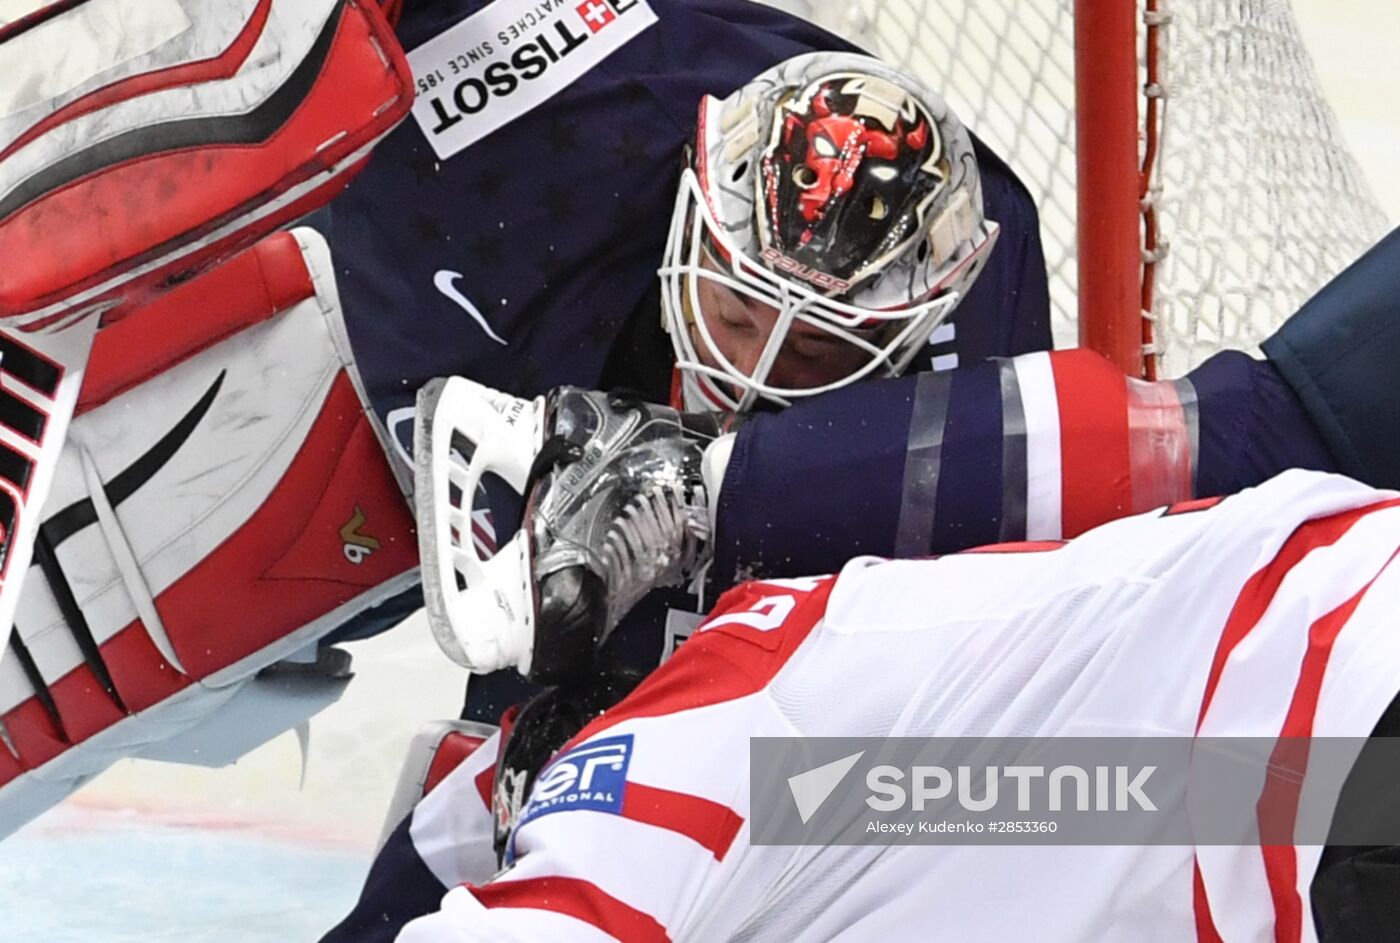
(0, 229, 417, 835)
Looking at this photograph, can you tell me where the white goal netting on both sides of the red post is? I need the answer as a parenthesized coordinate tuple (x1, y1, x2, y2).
(774, 0, 1386, 376)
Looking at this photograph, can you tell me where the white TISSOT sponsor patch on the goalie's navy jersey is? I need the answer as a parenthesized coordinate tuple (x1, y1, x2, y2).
(409, 0, 657, 159)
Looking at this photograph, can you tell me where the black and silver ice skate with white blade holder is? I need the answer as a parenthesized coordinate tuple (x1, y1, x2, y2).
(416, 378, 732, 681)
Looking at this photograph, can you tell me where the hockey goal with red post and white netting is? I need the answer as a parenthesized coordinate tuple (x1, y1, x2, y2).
(769, 0, 1387, 376)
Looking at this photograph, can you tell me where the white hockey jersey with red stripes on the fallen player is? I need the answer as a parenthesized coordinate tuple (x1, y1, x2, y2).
(399, 472, 1400, 943)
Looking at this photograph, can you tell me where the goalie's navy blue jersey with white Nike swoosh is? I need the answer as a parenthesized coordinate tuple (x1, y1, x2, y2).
(329, 0, 1050, 450)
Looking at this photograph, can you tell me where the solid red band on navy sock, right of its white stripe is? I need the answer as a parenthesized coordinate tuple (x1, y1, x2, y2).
(1050, 351, 1133, 537)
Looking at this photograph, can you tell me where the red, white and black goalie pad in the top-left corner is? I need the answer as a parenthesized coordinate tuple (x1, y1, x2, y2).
(0, 0, 413, 330)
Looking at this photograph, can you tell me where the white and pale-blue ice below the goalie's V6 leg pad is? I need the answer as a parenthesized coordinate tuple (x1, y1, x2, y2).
(0, 614, 466, 943)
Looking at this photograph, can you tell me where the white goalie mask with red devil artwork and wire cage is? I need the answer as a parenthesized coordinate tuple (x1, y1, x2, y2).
(659, 52, 998, 410)
